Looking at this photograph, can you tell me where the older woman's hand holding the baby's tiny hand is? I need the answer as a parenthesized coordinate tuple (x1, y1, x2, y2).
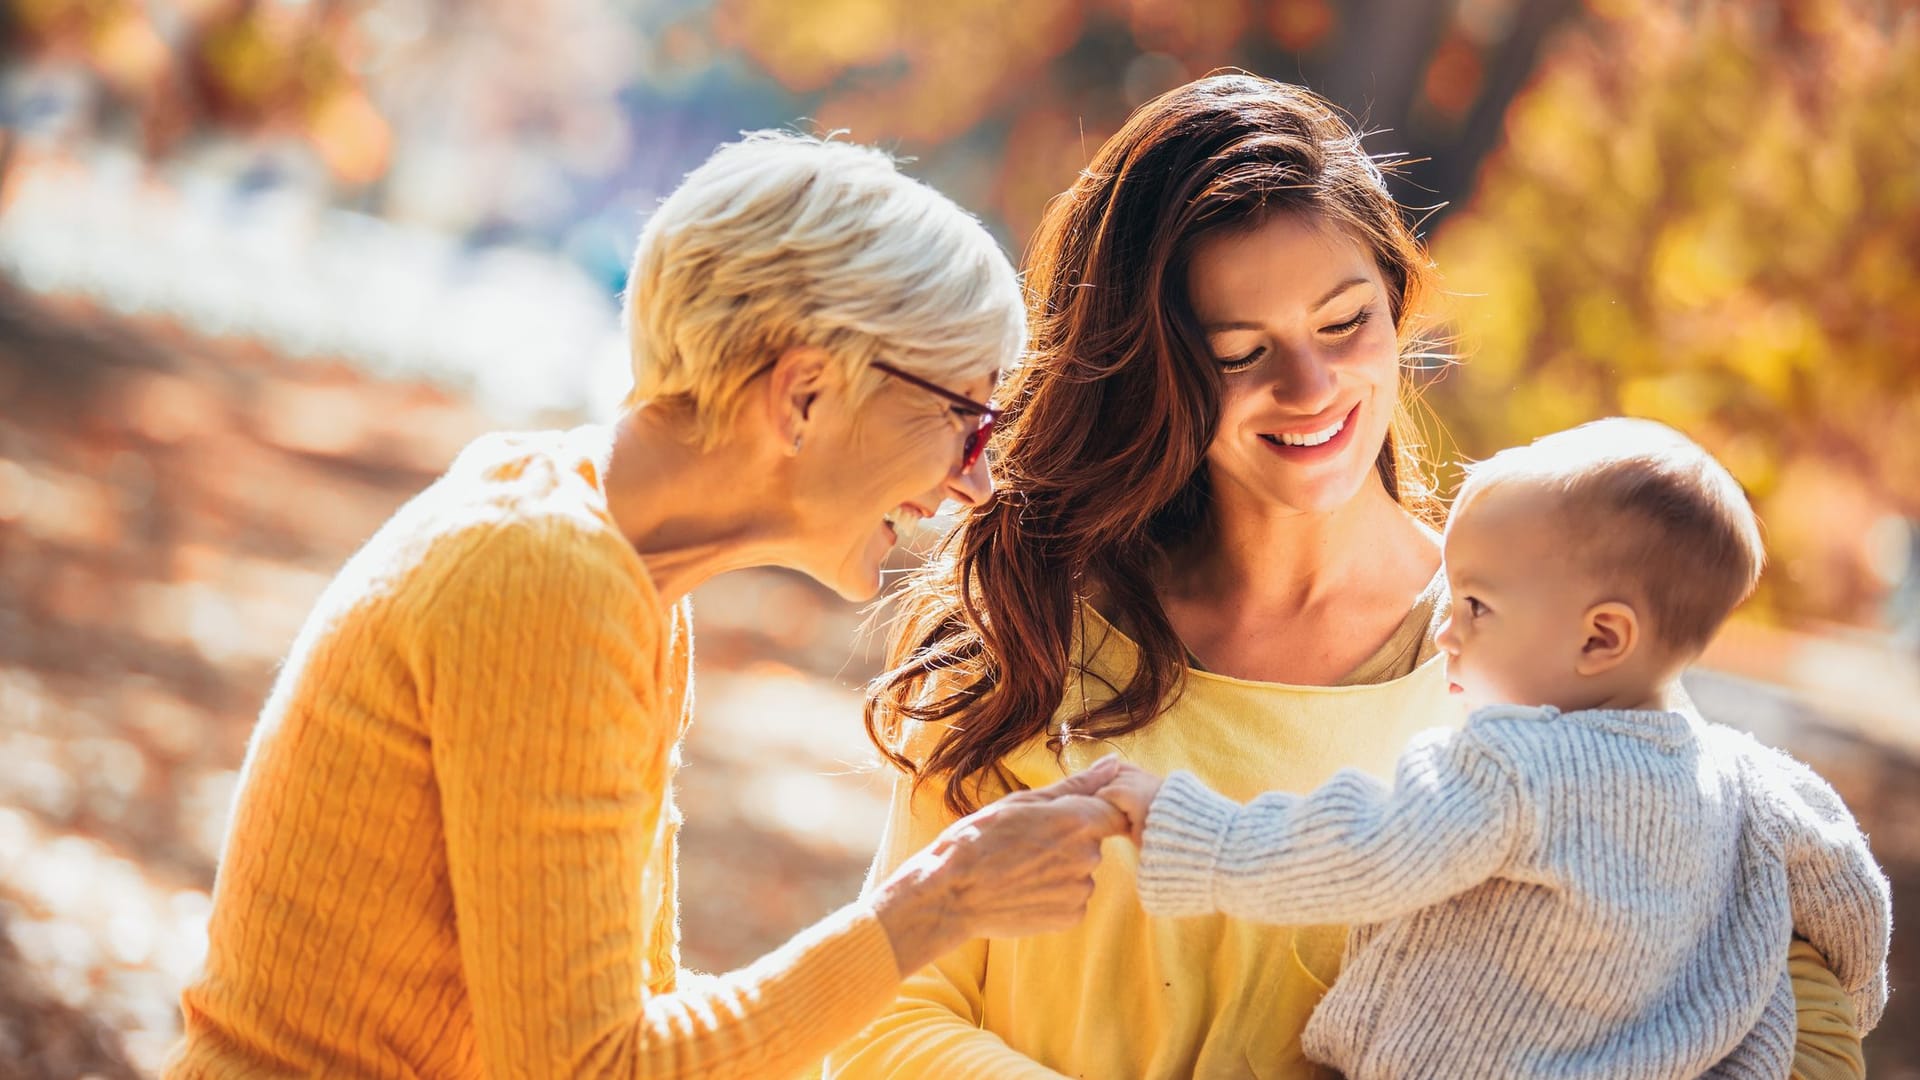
(874, 757, 1129, 976)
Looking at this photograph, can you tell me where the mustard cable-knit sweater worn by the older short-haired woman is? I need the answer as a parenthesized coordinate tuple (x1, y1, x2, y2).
(167, 429, 899, 1078)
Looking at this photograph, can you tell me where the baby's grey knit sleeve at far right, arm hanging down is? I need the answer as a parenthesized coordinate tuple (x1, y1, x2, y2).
(1755, 744, 1893, 1034)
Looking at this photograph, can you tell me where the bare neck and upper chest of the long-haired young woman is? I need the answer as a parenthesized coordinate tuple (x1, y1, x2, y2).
(1167, 477, 1440, 611)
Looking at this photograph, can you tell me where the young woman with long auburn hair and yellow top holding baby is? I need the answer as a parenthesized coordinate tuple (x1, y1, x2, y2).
(829, 75, 1859, 1080)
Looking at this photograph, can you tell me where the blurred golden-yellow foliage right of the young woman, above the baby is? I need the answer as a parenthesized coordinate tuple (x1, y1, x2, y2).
(1430, 0, 1920, 626)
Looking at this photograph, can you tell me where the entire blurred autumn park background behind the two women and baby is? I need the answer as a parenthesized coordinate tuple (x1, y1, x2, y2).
(0, 0, 1920, 1080)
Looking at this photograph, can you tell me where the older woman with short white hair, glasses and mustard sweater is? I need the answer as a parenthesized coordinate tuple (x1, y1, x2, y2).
(167, 135, 1123, 1078)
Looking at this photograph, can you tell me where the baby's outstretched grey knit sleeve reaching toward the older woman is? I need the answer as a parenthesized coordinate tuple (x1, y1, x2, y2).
(1140, 718, 1523, 924)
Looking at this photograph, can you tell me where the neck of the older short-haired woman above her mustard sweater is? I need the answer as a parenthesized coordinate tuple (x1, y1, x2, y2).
(605, 405, 787, 603)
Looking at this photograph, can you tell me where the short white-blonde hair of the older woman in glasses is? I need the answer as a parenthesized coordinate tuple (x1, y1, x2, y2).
(626, 131, 1027, 442)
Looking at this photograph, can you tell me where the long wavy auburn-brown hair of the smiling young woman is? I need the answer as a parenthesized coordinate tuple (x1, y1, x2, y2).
(866, 73, 1432, 815)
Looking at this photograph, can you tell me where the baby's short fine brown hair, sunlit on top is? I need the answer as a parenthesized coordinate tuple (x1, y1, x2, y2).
(1453, 417, 1766, 655)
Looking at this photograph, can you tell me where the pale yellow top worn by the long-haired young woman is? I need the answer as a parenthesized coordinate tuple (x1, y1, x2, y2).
(826, 599, 1862, 1080)
